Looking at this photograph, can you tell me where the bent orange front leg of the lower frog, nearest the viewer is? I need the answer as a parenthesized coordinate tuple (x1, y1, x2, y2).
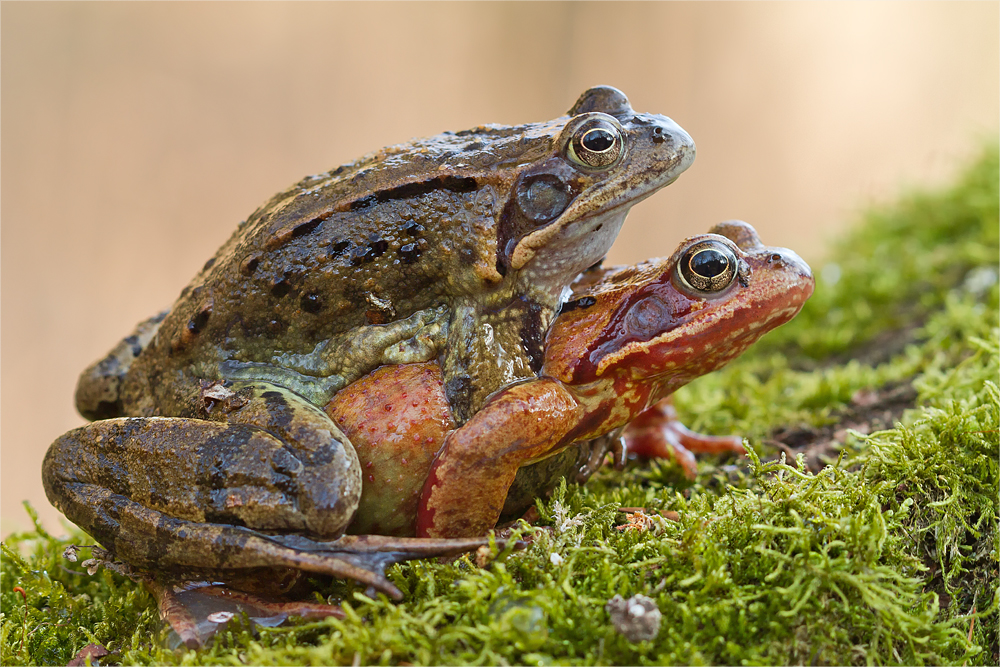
(417, 379, 581, 537)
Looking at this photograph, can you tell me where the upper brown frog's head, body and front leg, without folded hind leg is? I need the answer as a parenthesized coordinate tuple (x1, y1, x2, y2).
(77, 86, 695, 422)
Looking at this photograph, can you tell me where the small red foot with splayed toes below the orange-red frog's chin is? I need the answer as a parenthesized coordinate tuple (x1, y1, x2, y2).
(624, 398, 745, 479)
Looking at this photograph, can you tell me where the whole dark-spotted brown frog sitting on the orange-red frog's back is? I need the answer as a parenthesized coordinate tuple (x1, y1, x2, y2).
(43, 87, 694, 612)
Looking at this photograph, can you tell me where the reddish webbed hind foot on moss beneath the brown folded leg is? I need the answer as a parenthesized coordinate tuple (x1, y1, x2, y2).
(144, 579, 344, 648)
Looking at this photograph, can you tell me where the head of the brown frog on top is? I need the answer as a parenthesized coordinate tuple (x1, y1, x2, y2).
(497, 86, 695, 288)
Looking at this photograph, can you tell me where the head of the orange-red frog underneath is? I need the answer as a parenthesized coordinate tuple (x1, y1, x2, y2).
(543, 221, 814, 388)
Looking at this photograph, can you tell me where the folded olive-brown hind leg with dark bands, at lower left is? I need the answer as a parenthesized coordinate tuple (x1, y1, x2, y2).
(42, 382, 475, 597)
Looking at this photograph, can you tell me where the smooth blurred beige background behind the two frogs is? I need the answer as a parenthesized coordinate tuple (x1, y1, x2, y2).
(0, 2, 1000, 534)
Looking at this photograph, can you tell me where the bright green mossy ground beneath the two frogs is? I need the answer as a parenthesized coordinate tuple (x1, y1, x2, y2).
(0, 146, 1000, 665)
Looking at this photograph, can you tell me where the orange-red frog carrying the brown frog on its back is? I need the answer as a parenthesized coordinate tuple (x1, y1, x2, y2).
(326, 221, 814, 538)
